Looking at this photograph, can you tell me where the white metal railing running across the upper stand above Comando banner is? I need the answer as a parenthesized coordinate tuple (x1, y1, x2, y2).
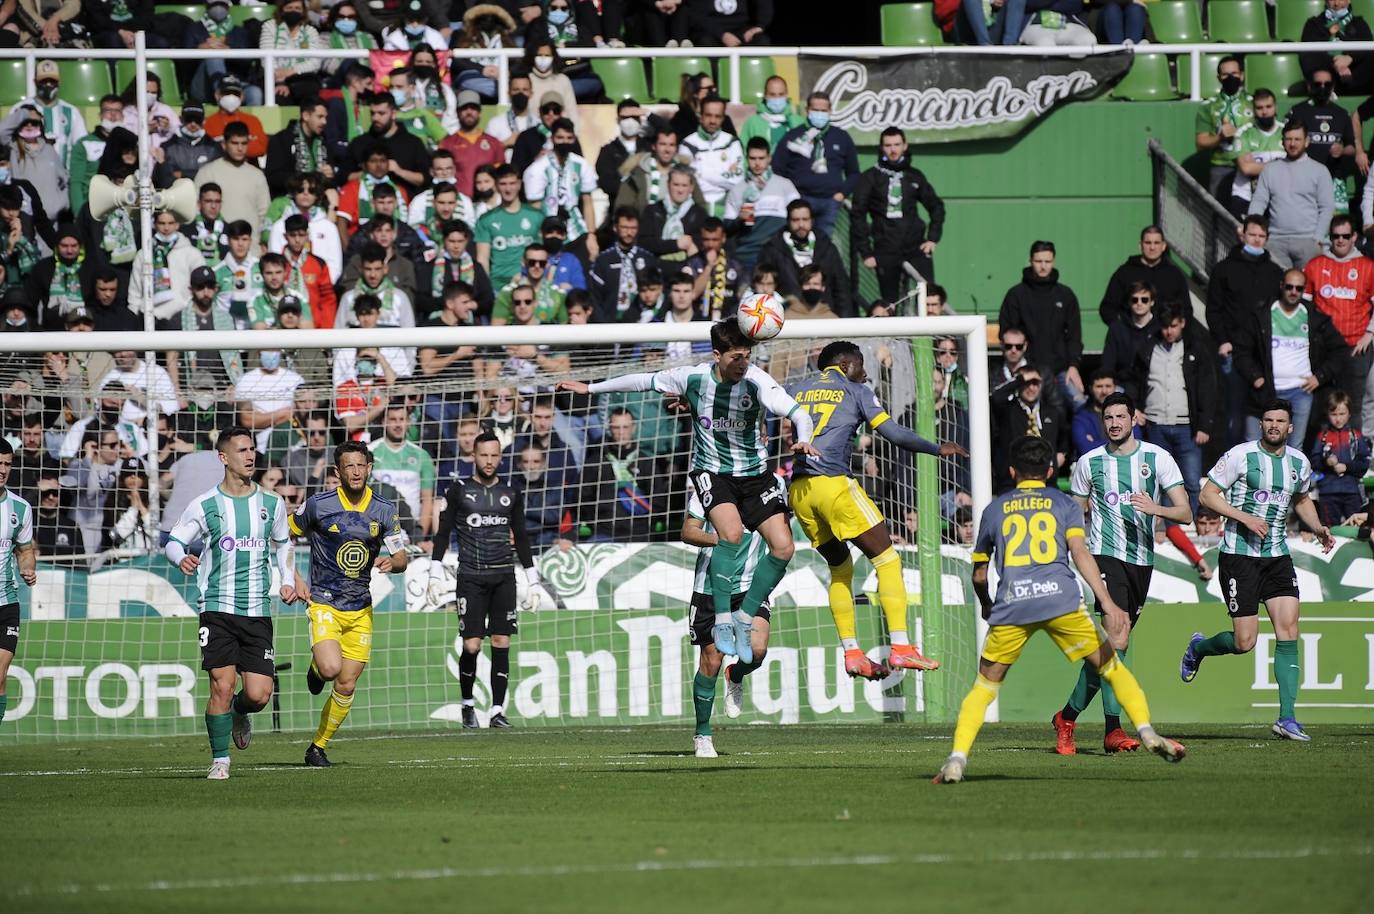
(0, 41, 1374, 104)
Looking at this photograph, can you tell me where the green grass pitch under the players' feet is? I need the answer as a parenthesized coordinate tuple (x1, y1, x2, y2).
(0, 720, 1374, 914)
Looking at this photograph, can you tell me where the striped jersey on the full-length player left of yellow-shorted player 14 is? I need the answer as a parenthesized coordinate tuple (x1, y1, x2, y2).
(172, 485, 291, 616)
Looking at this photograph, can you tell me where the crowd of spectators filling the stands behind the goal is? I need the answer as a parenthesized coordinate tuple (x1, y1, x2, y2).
(0, 0, 1374, 571)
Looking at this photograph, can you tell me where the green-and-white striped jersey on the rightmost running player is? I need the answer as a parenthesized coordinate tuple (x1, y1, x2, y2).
(1206, 441, 1312, 558)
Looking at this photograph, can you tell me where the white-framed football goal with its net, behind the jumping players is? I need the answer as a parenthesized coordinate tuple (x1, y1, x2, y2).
(0, 316, 991, 745)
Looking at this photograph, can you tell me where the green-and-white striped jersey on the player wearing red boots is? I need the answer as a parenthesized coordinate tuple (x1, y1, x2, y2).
(1069, 441, 1183, 565)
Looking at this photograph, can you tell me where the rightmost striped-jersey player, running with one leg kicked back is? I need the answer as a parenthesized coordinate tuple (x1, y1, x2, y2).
(1179, 399, 1336, 742)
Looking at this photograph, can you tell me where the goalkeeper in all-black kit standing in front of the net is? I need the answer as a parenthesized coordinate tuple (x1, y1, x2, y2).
(431, 432, 543, 730)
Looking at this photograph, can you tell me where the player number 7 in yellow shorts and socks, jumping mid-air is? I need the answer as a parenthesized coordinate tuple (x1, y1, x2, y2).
(787, 341, 969, 679)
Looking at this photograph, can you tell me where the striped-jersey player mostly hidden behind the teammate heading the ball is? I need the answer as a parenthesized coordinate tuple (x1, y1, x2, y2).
(682, 481, 771, 759)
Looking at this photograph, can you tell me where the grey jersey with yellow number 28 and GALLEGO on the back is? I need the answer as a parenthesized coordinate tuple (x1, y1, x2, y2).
(973, 482, 1084, 625)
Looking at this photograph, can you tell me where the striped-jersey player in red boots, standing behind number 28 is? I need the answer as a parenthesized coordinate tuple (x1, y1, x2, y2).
(1052, 393, 1193, 756)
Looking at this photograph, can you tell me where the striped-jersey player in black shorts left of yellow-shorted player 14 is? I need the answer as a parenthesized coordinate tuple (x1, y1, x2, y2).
(166, 426, 295, 781)
